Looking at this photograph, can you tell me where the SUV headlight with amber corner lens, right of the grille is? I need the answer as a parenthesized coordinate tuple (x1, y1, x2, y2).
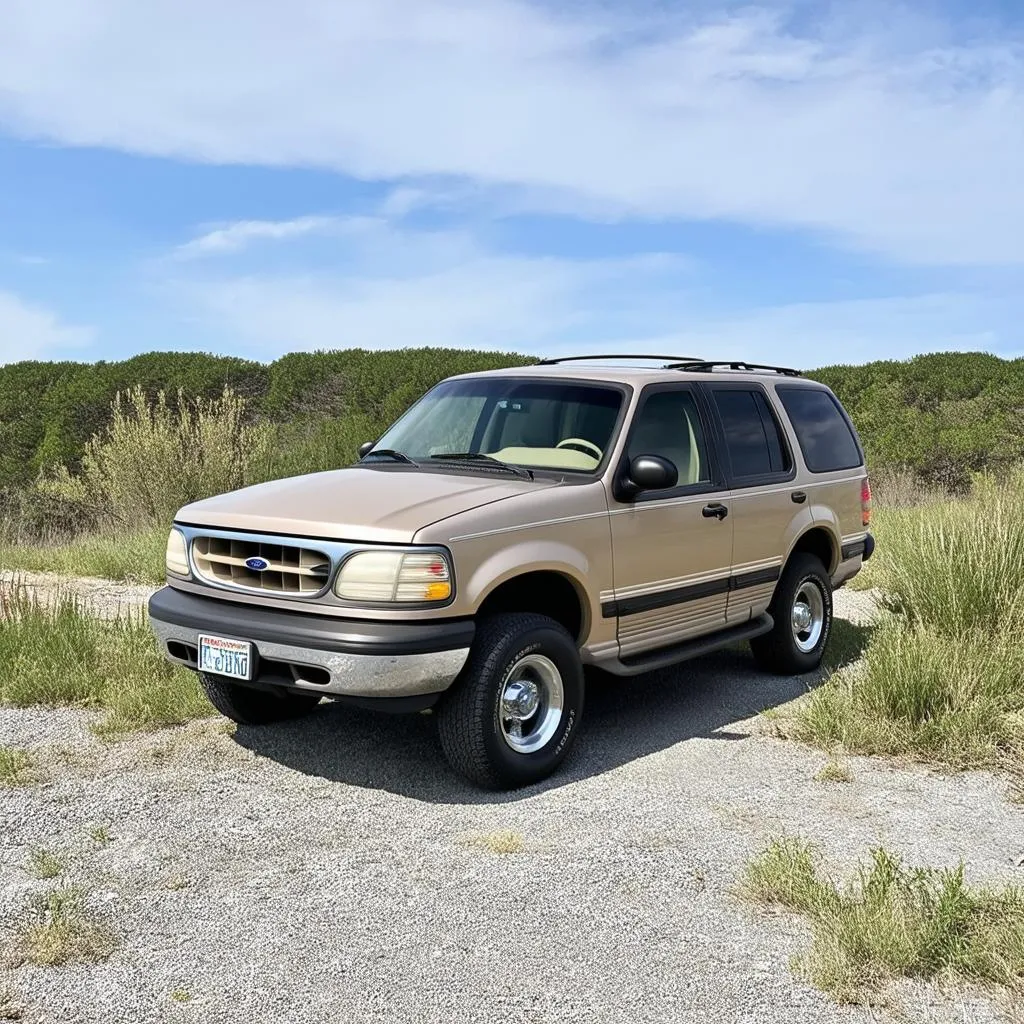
(334, 551, 452, 602)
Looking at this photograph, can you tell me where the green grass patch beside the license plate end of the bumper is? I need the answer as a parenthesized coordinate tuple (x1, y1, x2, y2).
(0, 590, 213, 735)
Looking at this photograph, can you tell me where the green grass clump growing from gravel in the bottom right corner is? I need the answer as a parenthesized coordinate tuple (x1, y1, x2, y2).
(740, 839, 1024, 999)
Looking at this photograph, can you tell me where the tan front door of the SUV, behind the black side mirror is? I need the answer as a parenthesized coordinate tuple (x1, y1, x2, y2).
(603, 384, 733, 657)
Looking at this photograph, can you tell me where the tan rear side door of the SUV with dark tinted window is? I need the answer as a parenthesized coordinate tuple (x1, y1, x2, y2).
(703, 381, 811, 625)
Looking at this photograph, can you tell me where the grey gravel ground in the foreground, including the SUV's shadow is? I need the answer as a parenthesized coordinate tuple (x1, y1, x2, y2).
(0, 591, 1024, 1024)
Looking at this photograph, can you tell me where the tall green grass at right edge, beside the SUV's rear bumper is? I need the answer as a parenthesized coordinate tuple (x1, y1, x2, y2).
(794, 473, 1024, 771)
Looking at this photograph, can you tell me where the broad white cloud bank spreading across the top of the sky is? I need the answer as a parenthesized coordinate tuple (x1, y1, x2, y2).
(0, 0, 1024, 264)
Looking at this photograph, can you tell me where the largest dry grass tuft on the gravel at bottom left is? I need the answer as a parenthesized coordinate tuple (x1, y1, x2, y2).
(11, 886, 118, 967)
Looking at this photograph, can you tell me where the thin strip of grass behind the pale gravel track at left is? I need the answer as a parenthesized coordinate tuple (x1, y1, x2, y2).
(0, 527, 167, 584)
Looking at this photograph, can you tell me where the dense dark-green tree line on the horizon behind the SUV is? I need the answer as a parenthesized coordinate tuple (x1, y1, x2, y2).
(0, 348, 1024, 487)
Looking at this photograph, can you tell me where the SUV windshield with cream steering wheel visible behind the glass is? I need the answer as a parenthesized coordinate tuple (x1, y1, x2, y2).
(374, 378, 623, 472)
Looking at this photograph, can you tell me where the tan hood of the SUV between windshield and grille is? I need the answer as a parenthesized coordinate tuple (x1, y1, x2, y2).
(175, 466, 558, 544)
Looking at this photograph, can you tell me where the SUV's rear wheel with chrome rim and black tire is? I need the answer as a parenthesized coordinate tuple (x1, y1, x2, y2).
(751, 552, 833, 676)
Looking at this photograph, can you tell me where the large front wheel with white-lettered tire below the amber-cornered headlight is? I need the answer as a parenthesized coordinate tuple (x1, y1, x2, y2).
(437, 612, 584, 790)
